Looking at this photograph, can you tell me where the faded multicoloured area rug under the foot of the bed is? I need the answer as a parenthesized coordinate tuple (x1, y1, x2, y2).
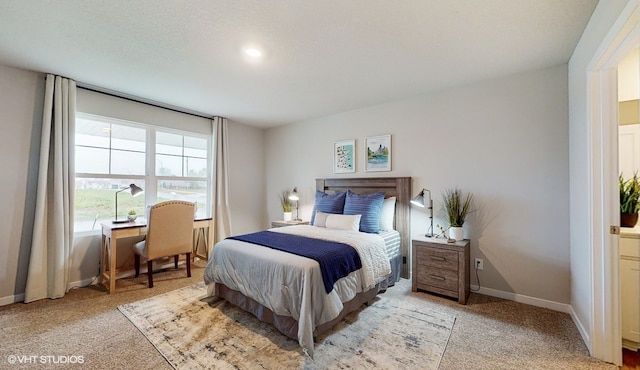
(118, 284, 455, 369)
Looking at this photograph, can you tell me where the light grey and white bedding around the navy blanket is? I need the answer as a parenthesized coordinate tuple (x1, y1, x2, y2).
(204, 225, 391, 356)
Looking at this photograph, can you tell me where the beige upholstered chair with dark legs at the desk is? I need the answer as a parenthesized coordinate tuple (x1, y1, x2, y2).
(133, 200, 195, 288)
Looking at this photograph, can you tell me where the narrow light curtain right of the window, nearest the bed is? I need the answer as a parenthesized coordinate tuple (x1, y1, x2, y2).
(211, 117, 231, 244)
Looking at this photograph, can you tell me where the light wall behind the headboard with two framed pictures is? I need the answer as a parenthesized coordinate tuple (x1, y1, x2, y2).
(265, 65, 570, 303)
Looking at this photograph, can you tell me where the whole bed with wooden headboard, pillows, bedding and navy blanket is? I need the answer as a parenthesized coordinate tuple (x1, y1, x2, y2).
(204, 177, 411, 356)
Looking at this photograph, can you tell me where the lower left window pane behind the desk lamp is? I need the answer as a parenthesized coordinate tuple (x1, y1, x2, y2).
(74, 178, 145, 232)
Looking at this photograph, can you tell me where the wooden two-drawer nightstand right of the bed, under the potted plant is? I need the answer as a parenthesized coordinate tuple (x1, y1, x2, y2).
(411, 236, 469, 304)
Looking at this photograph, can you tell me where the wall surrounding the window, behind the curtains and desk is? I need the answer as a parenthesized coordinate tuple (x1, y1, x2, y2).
(0, 65, 266, 305)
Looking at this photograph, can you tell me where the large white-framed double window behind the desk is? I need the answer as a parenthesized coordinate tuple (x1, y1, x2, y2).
(74, 113, 210, 232)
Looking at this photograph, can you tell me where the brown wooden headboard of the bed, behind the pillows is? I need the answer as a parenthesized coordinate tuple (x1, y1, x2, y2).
(316, 177, 411, 279)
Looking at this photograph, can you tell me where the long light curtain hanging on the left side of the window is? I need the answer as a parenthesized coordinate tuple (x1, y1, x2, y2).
(24, 75, 76, 302)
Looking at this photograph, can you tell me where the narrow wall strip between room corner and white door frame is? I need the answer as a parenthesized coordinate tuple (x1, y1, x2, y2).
(569, 0, 635, 352)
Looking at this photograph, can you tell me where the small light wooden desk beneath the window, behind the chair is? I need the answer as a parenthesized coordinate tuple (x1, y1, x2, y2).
(100, 217, 213, 293)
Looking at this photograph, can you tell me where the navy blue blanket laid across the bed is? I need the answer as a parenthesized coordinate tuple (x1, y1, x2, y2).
(228, 231, 362, 294)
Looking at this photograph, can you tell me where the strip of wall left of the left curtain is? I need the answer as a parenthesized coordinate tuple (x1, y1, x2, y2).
(0, 65, 44, 304)
